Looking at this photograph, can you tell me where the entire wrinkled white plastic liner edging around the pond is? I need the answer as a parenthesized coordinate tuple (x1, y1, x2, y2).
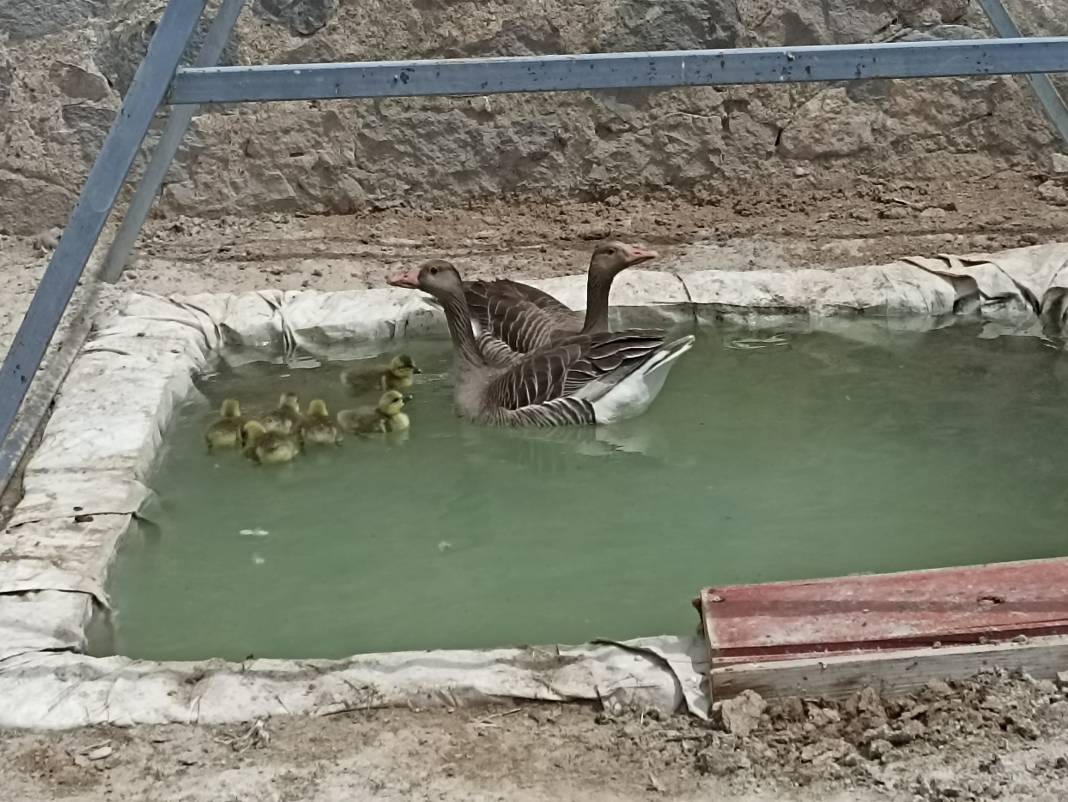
(0, 243, 1068, 727)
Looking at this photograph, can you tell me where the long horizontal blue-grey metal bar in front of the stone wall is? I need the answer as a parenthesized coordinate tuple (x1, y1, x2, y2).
(168, 36, 1068, 104)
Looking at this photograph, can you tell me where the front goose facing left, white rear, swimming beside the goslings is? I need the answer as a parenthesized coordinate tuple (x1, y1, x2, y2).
(389, 260, 694, 426)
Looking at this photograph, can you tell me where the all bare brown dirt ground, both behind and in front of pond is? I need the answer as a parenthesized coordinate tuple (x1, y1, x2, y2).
(0, 173, 1068, 802)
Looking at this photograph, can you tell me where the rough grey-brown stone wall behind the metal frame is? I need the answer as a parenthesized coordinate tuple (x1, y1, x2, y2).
(0, 0, 1068, 233)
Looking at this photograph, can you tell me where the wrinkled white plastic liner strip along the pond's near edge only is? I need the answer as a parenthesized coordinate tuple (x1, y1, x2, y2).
(0, 638, 708, 729)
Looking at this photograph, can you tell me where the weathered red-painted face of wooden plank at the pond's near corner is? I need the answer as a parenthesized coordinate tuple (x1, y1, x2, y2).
(700, 559, 1068, 665)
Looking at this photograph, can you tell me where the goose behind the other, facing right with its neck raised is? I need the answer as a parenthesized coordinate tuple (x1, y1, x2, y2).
(420, 240, 657, 365)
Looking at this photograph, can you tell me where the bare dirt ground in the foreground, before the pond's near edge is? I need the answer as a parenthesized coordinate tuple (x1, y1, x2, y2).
(0, 673, 1068, 802)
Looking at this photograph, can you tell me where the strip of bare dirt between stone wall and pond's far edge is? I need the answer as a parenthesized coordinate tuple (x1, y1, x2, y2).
(0, 172, 1068, 349)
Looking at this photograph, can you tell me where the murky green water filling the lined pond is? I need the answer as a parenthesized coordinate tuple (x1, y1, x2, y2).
(109, 327, 1068, 659)
